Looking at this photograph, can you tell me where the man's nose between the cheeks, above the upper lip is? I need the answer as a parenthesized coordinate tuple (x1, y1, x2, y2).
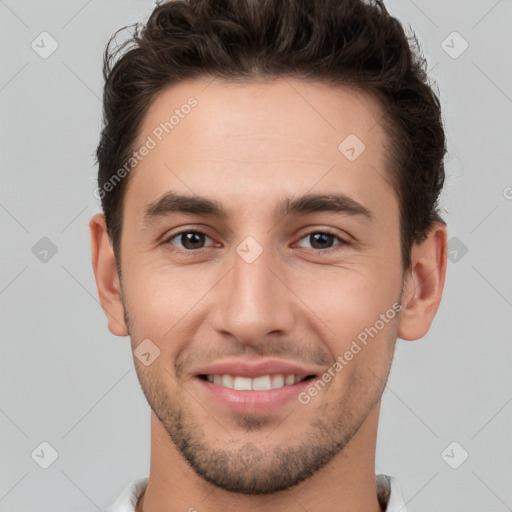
(213, 241, 297, 345)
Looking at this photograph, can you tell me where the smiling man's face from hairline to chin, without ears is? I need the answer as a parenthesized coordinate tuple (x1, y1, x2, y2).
(116, 79, 403, 493)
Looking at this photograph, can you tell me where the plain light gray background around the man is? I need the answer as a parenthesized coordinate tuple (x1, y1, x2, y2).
(0, 0, 512, 512)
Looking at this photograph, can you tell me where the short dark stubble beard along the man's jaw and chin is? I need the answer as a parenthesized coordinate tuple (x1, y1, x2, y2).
(134, 360, 381, 494)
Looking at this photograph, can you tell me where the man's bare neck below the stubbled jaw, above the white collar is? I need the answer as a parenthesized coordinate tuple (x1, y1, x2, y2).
(136, 403, 382, 512)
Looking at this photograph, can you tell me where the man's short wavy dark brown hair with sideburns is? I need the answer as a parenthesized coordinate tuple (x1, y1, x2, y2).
(96, 0, 446, 269)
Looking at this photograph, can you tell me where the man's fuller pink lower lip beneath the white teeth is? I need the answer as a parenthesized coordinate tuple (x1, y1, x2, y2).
(196, 377, 314, 414)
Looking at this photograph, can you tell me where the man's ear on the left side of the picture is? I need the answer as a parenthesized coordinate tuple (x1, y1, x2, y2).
(89, 213, 129, 336)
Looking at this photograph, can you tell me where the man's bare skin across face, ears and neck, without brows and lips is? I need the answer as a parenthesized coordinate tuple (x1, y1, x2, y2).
(90, 78, 446, 512)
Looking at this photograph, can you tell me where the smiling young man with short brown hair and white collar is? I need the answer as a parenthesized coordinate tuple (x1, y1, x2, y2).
(90, 0, 446, 512)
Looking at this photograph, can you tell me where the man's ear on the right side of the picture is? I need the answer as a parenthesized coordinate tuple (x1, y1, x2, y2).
(398, 222, 447, 340)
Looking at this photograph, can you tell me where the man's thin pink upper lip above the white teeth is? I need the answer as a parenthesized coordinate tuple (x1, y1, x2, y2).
(195, 359, 317, 378)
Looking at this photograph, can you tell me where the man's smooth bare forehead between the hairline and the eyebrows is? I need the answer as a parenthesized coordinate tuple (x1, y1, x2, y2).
(127, 78, 391, 221)
